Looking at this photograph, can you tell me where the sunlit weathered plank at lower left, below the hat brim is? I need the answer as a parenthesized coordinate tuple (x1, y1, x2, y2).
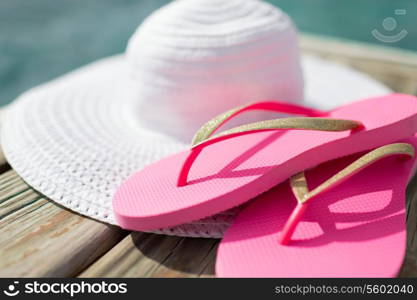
(0, 170, 127, 277)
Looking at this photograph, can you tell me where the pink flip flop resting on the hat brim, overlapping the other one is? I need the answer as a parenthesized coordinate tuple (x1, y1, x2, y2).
(113, 94, 417, 230)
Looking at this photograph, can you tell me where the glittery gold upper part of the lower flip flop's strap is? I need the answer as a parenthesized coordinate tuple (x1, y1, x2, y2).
(290, 143, 414, 203)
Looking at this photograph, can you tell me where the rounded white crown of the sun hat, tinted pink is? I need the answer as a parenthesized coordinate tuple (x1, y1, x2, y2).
(127, 0, 303, 140)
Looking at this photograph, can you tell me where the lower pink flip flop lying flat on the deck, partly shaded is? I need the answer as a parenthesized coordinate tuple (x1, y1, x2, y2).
(216, 137, 417, 277)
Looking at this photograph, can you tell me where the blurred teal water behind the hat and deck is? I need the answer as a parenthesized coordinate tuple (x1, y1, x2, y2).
(0, 0, 417, 105)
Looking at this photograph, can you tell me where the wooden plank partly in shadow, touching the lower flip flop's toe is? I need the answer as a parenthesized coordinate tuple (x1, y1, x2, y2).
(79, 232, 218, 277)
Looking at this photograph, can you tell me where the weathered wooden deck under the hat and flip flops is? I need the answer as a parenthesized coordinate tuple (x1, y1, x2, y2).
(0, 36, 417, 277)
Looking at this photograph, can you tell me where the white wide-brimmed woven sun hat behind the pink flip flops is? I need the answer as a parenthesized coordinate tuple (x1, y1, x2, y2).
(1, 0, 389, 238)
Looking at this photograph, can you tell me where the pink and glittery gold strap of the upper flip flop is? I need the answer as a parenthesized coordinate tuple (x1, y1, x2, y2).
(177, 101, 362, 187)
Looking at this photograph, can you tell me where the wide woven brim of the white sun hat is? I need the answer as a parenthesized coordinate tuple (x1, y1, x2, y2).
(1, 55, 390, 238)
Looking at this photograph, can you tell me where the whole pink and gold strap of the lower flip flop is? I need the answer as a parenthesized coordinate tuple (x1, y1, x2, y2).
(279, 143, 414, 245)
